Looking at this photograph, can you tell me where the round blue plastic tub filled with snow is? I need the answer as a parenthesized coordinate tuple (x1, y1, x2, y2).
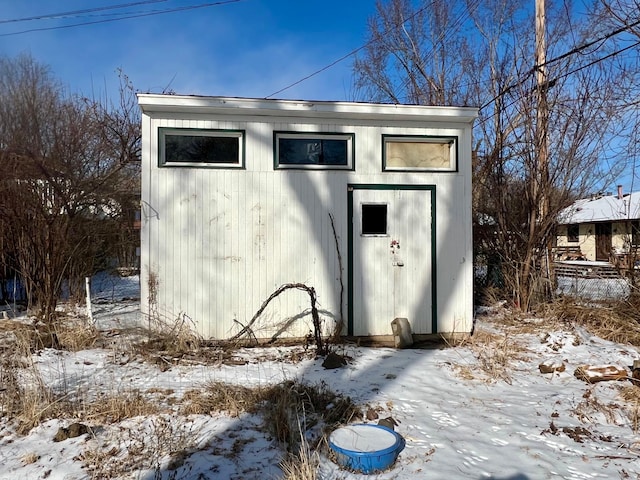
(329, 423, 405, 474)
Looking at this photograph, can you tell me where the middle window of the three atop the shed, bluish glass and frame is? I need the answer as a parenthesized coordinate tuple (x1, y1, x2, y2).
(273, 132, 354, 169)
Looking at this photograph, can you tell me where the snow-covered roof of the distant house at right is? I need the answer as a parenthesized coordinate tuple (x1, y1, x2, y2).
(558, 192, 640, 225)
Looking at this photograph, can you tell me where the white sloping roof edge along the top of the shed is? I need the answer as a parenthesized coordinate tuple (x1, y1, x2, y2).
(138, 93, 478, 123)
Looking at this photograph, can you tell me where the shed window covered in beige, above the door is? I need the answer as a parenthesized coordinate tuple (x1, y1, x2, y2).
(382, 135, 458, 172)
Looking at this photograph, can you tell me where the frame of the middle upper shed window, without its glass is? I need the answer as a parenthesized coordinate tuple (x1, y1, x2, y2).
(273, 130, 356, 170)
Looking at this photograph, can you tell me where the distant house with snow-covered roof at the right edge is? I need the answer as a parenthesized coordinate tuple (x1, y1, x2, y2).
(557, 186, 640, 266)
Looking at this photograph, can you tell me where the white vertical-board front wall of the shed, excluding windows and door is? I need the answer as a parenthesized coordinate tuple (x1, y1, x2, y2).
(141, 114, 472, 338)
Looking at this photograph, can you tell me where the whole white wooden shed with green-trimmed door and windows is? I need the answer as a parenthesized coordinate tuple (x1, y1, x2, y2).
(138, 94, 477, 339)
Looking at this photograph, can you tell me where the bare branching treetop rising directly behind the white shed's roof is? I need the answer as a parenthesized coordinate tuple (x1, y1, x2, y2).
(354, 0, 467, 105)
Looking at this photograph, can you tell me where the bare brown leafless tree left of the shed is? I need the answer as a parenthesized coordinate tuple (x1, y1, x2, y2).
(0, 55, 139, 322)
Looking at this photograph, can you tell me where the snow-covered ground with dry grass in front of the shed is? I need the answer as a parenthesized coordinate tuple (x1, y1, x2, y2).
(0, 277, 640, 480)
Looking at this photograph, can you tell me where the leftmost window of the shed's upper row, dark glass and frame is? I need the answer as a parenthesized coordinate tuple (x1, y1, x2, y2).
(158, 128, 244, 168)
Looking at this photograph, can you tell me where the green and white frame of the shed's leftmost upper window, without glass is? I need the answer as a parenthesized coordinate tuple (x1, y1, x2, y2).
(158, 127, 246, 169)
